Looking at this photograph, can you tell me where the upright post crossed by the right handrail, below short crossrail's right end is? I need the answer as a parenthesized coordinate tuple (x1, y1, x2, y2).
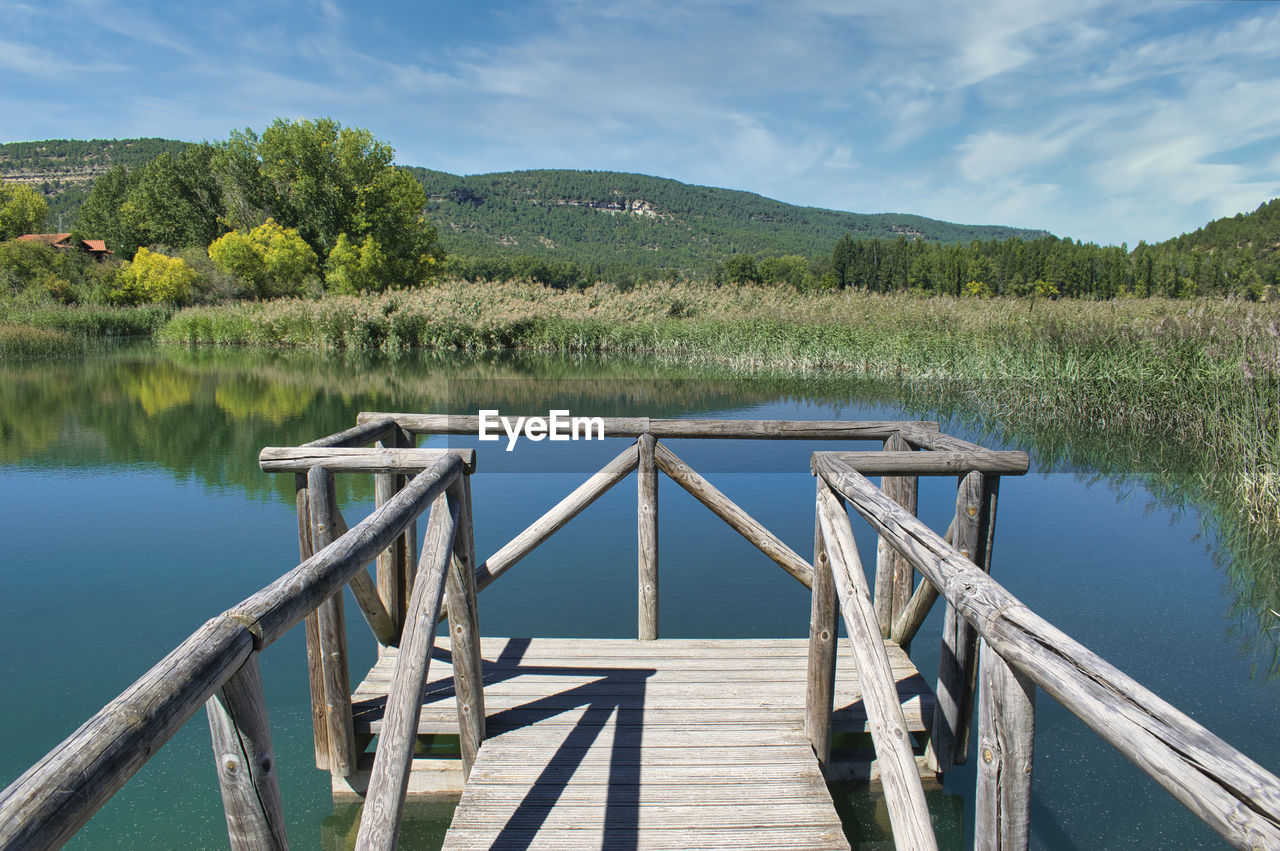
(929, 472, 1000, 774)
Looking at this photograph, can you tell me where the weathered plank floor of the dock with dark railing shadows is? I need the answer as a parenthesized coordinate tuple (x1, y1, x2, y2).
(352, 639, 933, 848)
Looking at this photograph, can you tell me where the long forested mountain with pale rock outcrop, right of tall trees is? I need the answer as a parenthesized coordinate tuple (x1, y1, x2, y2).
(408, 168, 1048, 274)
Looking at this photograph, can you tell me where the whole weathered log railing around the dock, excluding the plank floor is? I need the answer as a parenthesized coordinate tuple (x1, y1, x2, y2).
(0, 413, 1280, 848)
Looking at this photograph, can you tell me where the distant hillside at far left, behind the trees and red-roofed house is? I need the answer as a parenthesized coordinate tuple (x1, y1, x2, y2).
(0, 138, 187, 230)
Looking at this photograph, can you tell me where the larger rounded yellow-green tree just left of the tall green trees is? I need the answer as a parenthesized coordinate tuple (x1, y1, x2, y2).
(209, 219, 319, 298)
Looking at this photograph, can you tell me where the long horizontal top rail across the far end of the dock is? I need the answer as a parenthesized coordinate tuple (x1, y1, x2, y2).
(356, 411, 938, 440)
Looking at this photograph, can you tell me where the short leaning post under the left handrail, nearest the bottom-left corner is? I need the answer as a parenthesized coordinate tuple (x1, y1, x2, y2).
(205, 653, 289, 851)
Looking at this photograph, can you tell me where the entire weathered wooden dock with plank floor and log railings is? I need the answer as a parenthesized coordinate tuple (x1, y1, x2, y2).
(0, 413, 1280, 851)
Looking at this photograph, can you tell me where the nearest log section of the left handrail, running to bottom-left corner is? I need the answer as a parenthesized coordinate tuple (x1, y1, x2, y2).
(0, 614, 253, 848)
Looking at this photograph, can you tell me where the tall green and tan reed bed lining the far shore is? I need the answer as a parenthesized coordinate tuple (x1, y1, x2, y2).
(157, 282, 1280, 529)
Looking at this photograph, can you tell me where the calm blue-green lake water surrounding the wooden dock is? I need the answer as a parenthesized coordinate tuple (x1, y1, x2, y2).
(0, 347, 1280, 848)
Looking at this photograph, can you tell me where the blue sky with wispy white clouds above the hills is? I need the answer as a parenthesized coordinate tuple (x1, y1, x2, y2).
(0, 0, 1280, 247)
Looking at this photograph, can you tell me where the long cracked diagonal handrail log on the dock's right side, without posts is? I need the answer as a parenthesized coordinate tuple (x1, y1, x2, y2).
(813, 452, 1280, 847)
